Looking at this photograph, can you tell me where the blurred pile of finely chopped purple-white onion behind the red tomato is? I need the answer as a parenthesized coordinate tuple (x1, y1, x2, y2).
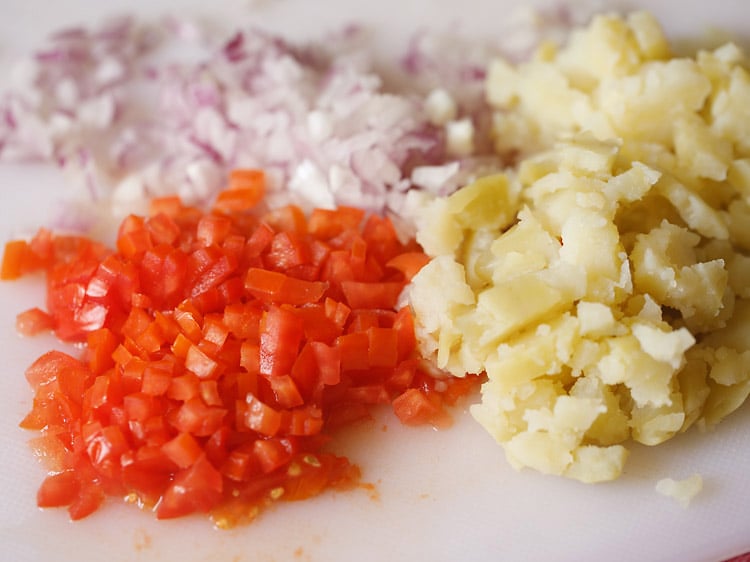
(0, 7, 588, 229)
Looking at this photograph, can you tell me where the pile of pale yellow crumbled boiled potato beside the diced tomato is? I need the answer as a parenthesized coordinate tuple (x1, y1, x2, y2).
(408, 12, 750, 482)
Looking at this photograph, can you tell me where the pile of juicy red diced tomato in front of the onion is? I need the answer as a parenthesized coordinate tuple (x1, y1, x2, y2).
(0, 170, 477, 526)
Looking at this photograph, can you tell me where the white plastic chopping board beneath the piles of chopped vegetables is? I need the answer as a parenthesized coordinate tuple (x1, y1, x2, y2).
(0, 0, 750, 562)
